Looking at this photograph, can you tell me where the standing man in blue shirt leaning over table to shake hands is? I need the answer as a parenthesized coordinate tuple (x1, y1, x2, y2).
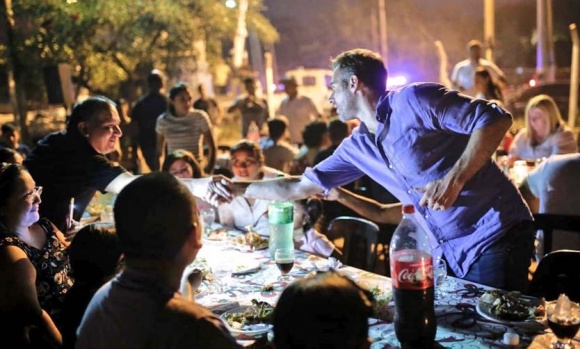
(206, 49, 534, 291)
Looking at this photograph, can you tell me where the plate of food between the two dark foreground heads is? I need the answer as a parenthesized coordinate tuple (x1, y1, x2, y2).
(220, 299, 274, 336)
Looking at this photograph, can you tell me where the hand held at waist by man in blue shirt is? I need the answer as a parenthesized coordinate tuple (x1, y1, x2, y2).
(416, 176, 463, 211)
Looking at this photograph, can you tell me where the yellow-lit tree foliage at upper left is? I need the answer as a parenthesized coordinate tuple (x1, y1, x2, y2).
(3, 0, 278, 99)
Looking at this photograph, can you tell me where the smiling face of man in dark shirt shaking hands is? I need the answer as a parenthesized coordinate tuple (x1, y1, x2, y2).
(88, 108, 123, 154)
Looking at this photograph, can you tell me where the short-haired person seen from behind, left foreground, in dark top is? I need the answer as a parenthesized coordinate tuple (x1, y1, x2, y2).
(76, 172, 240, 349)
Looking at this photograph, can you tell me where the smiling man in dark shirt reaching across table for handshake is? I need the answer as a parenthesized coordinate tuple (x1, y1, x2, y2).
(24, 96, 215, 231)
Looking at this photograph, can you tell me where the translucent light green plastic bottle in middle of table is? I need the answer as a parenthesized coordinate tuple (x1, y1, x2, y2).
(268, 201, 294, 259)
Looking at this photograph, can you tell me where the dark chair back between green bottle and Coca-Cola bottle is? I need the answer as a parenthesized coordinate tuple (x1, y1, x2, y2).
(327, 216, 379, 271)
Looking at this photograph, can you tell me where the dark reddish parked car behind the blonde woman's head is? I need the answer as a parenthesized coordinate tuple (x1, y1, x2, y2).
(505, 81, 580, 121)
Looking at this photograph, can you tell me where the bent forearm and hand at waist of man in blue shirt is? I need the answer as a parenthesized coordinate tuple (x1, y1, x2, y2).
(419, 117, 512, 210)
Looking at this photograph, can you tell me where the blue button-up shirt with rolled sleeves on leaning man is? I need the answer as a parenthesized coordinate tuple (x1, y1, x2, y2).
(304, 83, 532, 277)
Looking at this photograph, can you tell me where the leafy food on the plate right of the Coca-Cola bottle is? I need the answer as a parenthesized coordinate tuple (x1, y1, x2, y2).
(479, 290, 543, 321)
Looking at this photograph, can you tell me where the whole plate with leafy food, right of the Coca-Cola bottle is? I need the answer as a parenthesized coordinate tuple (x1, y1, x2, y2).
(476, 290, 545, 325)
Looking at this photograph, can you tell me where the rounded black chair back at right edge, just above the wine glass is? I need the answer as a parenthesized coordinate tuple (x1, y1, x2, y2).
(529, 250, 580, 302)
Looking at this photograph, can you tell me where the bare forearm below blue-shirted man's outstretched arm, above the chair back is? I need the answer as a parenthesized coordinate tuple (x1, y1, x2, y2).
(324, 188, 403, 224)
